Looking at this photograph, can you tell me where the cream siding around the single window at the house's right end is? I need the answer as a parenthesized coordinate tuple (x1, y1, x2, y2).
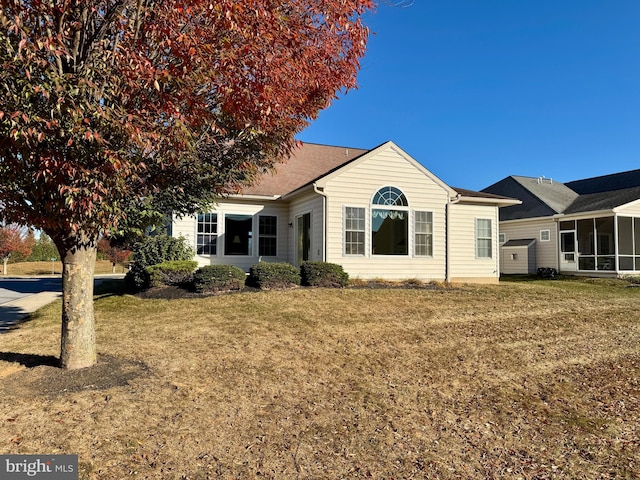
(449, 203, 499, 282)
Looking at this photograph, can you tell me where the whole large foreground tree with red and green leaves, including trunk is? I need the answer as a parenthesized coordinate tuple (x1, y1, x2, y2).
(0, 0, 373, 368)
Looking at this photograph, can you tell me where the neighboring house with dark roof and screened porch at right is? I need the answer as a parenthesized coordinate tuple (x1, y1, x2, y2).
(483, 170, 640, 276)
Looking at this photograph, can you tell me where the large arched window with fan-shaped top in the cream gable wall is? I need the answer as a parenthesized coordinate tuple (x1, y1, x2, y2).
(371, 187, 409, 255)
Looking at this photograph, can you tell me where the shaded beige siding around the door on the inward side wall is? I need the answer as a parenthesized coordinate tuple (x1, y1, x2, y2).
(287, 191, 324, 264)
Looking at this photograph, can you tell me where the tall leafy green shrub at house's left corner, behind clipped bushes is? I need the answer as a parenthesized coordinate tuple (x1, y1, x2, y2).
(125, 235, 195, 292)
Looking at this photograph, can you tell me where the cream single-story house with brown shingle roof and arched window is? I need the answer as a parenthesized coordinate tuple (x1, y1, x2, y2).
(171, 142, 519, 283)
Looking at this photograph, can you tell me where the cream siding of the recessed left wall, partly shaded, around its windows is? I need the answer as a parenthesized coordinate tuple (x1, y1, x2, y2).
(172, 200, 289, 271)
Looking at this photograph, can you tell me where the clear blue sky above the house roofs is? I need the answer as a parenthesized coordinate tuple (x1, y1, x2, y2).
(298, 0, 640, 190)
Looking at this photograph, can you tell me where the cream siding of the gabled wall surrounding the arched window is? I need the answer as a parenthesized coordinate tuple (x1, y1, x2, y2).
(323, 149, 448, 280)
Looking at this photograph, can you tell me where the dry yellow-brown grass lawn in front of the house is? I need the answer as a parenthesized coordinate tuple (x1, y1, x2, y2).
(0, 280, 640, 479)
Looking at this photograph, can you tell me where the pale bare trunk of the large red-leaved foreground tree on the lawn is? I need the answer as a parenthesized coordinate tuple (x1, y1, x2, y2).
(60, 235, 97, 369)
